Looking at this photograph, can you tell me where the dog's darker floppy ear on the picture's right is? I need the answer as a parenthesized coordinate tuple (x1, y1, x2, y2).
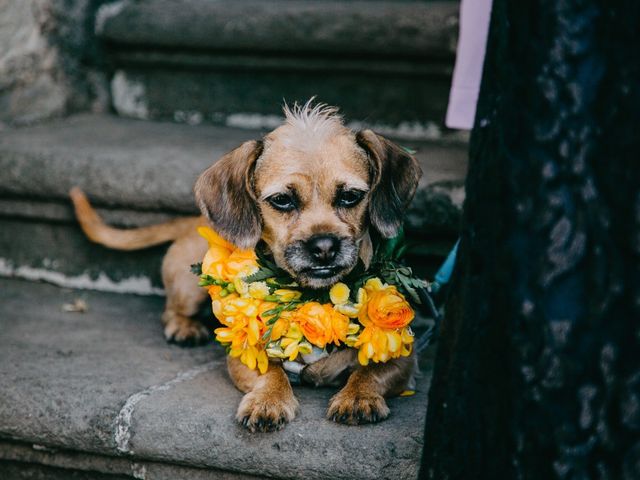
(356, 130, 422, 238)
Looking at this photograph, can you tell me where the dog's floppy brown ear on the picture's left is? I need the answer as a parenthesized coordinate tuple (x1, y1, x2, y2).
(194, 141, 262, 249)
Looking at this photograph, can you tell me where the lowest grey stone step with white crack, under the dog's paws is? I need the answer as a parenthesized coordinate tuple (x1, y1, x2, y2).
(0, 280, 430, 479)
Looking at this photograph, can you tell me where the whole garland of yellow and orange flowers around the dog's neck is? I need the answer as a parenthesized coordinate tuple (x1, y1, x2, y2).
(198, 227, 414, 373)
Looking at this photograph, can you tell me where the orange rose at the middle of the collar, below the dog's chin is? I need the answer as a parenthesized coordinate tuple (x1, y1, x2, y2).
(293, 302, 349, 348)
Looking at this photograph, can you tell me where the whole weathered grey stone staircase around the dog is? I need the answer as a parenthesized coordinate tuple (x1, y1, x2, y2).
(0, 0, 467, 480)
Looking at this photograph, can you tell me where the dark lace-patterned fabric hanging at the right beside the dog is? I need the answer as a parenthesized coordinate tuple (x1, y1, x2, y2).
(422, 0, 640, 480)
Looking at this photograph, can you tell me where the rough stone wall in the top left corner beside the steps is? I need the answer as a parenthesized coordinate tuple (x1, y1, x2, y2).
(0, 0, 108, 125)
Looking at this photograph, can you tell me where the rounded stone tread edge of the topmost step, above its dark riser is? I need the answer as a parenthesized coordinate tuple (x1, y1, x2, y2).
(98, 0, 458, 58)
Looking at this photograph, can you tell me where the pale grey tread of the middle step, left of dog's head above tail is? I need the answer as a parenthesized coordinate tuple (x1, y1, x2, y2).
(0, 115, 252, 213)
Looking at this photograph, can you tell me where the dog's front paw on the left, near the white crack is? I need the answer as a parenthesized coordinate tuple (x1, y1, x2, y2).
(236, 392, 298, 432)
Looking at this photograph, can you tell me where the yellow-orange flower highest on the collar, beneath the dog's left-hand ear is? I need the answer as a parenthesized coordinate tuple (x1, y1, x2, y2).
(198, 227, 258, 282)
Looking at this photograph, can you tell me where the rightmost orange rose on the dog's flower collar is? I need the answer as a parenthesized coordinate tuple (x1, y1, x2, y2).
(358, 286, 414, 330)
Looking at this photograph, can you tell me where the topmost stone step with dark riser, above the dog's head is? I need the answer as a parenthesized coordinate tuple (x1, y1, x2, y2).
(96, 0, 458, 130)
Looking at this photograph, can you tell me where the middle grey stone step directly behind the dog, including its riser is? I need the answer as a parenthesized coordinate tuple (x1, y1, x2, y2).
(0, 114, 466, 294)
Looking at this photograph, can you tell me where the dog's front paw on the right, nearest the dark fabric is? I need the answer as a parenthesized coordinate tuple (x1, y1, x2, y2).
(327, 390, 389, 425)
